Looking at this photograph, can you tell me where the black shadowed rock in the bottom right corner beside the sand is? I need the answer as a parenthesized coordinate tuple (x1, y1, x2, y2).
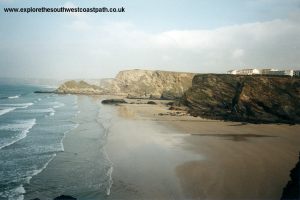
(281, 154, 300, 200)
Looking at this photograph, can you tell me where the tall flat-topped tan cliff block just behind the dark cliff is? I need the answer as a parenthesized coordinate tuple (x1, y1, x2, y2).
(115, 70, 194, 99)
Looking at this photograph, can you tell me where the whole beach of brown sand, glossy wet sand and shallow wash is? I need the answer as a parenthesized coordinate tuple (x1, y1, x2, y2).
(25, 96, 300, 199)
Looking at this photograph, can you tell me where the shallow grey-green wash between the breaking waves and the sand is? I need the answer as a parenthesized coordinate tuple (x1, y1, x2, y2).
(25, 96, 110, 199)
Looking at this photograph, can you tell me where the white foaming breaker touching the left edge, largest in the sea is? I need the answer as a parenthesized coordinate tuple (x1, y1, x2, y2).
(0, 119, 36, 149)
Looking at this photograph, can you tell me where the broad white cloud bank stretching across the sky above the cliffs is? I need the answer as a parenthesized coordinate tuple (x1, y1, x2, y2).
(0, 12, 300, 78)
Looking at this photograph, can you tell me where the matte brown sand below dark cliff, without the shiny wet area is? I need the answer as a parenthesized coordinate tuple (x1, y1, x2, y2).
(120, 101, 300, 199)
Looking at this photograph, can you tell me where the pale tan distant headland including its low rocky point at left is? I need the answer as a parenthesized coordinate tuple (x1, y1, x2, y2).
(56, 69, 195, 99)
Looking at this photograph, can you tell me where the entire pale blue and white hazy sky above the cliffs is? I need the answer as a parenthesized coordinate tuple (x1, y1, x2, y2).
(0, 0, 300, 78)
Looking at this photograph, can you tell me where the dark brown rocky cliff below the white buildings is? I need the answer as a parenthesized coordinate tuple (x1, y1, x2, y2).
(183, 74, 300, 123)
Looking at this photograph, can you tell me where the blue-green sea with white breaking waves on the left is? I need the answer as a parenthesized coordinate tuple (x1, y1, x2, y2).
(0, 83, 78, 200)
